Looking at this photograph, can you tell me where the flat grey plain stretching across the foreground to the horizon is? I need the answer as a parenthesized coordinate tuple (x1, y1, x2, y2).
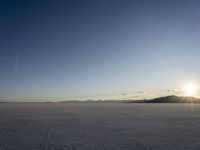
(0, 103, 200, 150)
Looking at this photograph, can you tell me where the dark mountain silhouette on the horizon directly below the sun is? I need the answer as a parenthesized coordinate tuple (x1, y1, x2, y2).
(143, 95, 200, 103)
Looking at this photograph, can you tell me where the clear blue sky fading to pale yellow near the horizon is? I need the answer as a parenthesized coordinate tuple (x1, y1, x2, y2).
(0, 0, 200, 101)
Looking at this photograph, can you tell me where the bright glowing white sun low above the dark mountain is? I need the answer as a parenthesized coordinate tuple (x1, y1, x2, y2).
(184, 83, 198, 96)
